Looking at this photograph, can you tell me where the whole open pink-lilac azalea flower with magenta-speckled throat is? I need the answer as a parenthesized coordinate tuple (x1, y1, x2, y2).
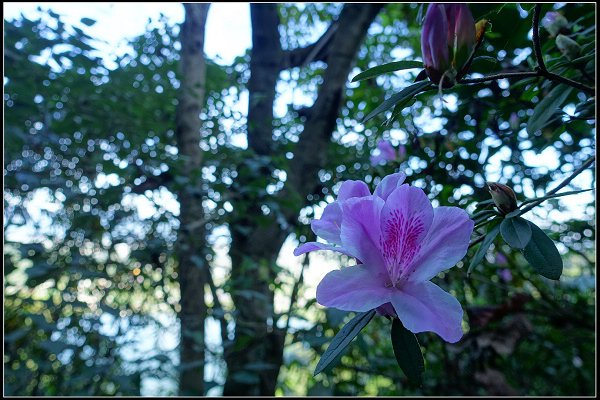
(294, 173, 473, 343)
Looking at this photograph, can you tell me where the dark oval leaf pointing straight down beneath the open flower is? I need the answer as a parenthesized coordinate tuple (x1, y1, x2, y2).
(392, 318, 425, 384)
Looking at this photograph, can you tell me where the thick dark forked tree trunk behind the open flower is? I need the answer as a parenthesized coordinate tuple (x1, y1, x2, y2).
(223, 4, 382, 396)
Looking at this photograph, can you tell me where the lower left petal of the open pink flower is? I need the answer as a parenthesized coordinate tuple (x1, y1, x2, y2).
(317, 264, 392, 312)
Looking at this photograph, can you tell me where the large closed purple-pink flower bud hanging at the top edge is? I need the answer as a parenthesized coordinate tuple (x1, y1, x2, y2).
(421, 4, 475, 86)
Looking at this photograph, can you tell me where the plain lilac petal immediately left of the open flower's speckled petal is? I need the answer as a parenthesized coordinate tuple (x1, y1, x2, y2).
(340, 196, 385, 270)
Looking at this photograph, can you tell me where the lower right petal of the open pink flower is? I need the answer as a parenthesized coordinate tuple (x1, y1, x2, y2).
(391, 282, 463, 343)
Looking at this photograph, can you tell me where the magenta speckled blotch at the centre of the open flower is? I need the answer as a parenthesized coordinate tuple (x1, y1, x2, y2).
(379, 210, 425, 287)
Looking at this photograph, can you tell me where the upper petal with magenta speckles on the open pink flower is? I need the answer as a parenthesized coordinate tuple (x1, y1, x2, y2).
(379, 184, 433, 284)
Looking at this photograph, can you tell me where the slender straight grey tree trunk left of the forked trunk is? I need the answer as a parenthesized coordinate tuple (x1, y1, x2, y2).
(177, 4, 210, 396)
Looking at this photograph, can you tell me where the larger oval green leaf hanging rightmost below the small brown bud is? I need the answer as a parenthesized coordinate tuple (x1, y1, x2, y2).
(523, 222, 563, 280)
